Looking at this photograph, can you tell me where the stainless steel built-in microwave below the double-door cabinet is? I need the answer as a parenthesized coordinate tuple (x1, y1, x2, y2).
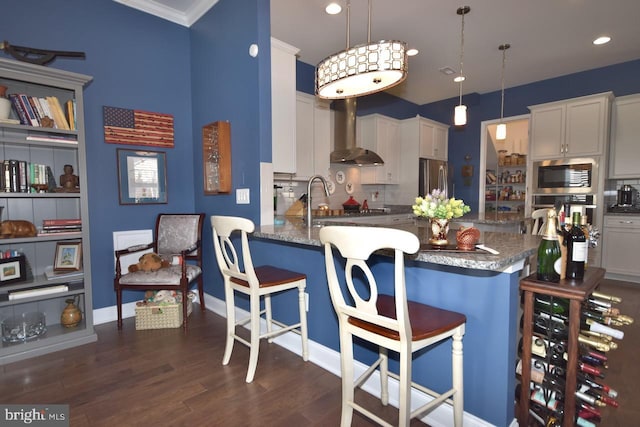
(532, 158, 598, 194)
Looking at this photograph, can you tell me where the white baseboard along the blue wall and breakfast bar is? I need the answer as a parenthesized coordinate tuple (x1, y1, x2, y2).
(93, 294, 504, 427)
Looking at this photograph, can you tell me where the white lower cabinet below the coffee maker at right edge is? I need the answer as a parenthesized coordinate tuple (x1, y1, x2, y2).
(602, 215, 640, 282)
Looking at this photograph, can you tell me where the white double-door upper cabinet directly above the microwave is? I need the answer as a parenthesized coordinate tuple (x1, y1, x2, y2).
(529, 92, 613, 160)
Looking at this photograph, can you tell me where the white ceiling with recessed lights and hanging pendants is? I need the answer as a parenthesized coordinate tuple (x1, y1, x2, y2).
(114, 0, 640, 105)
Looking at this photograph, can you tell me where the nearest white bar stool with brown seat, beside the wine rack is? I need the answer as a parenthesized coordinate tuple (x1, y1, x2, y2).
(320, 226, 466, 427)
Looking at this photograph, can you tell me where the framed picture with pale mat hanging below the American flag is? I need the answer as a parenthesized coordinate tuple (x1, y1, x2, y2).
(116, 148, 167, 205)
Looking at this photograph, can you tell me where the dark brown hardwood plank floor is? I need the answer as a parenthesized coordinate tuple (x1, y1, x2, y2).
(0, 281, 640, 427)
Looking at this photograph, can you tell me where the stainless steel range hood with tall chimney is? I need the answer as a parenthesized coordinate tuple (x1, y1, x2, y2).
(329, 97, 384, 165)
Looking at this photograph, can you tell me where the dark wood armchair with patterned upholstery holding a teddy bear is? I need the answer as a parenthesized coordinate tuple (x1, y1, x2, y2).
(113, 214, 205, 331)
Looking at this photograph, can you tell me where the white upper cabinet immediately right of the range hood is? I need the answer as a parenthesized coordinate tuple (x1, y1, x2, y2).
(356, 114, 400, 184)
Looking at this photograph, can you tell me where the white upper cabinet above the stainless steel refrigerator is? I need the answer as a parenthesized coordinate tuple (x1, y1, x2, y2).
(400, 116, 449, 161)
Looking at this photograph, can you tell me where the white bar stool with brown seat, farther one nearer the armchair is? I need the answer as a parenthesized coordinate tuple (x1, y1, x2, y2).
(211, 216, 309, 383)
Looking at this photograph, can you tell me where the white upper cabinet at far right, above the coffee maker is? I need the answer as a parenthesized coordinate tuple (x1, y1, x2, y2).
(609, 94, 640, 179)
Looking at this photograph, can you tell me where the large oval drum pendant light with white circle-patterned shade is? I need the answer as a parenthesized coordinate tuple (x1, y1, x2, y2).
(316, 0, 407, 99)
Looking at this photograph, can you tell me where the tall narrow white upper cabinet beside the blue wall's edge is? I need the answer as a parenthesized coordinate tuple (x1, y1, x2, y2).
(271, 37, 299, 173)
